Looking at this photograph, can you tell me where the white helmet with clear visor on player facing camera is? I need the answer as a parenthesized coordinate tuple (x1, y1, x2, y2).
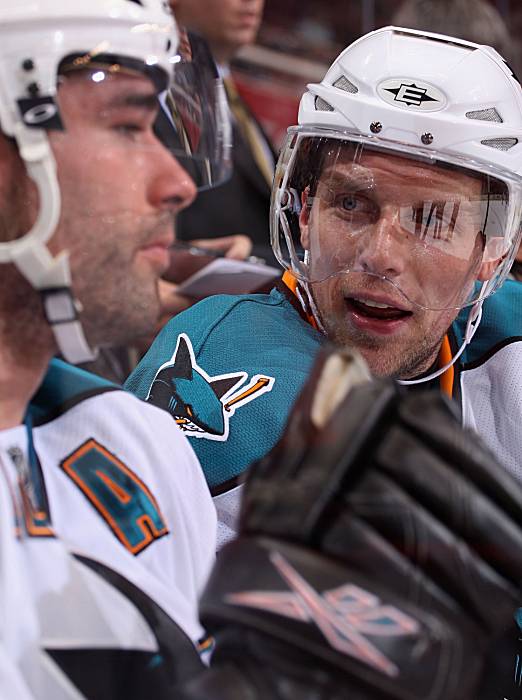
(270, 27, 522, 309)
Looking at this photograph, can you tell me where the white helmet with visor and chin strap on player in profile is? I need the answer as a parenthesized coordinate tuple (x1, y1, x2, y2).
(0, 0, 229, 362)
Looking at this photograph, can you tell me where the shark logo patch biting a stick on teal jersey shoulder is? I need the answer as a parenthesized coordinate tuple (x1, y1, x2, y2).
(146, 333, 275, 442)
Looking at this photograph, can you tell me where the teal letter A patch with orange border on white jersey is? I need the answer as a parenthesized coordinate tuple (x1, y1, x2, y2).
(61, 438, 169, 554)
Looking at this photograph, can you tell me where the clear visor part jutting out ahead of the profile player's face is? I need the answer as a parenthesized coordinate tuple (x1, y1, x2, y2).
(155, 31, 232, 190)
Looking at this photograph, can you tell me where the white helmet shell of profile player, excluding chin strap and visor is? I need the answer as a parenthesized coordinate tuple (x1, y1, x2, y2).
(0, 0, 177, 136)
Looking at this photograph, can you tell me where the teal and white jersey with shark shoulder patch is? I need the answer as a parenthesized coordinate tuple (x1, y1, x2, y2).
(125, 282, 522, 541)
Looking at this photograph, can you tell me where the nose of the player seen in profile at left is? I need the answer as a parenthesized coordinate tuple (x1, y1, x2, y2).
(148, 143, 197, 214)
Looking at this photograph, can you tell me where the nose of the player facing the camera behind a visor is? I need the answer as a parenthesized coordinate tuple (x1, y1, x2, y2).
(355, 205, 408, 278)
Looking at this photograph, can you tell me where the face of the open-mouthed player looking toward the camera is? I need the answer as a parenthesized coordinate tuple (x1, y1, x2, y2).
(301, 152, 488, 378)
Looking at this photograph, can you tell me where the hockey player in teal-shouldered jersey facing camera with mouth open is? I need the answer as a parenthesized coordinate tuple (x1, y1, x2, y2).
(126, 28, 522, 539)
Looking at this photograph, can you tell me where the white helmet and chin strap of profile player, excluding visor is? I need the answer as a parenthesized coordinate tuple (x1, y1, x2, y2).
(0, 0, 178, 362)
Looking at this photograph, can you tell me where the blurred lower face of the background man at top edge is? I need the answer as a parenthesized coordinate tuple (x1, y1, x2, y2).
(171, 0, 264, 51)
